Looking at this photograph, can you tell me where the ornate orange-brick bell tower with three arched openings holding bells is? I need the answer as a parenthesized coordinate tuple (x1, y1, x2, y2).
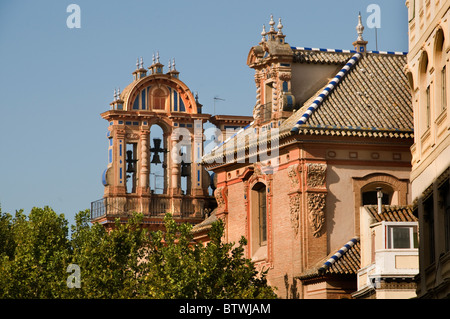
(91, 52, 215, 229)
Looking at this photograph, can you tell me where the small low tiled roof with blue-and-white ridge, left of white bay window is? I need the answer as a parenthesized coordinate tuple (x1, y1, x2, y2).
(298, 238, 361, 279)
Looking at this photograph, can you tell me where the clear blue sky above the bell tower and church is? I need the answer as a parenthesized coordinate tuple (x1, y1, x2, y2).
(0, 0, 408, 223)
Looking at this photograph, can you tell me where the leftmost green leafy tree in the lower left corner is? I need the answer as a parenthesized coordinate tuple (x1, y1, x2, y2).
(0, 207, 70, 298)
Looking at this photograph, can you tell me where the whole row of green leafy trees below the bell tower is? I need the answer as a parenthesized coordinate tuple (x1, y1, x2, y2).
(0, 207, 275, 299)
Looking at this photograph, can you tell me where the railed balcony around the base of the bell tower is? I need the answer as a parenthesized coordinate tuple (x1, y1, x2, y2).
(91, 195, 198, 220)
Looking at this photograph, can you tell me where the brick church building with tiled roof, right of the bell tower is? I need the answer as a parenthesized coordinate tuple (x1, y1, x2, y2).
(200, 16, 418, 298)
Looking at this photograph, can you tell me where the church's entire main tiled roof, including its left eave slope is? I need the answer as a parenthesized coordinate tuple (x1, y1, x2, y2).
(204, 48, 414, 162)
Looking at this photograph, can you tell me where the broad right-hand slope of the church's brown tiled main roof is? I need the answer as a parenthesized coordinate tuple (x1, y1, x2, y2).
(280, 52, 414, 137)
